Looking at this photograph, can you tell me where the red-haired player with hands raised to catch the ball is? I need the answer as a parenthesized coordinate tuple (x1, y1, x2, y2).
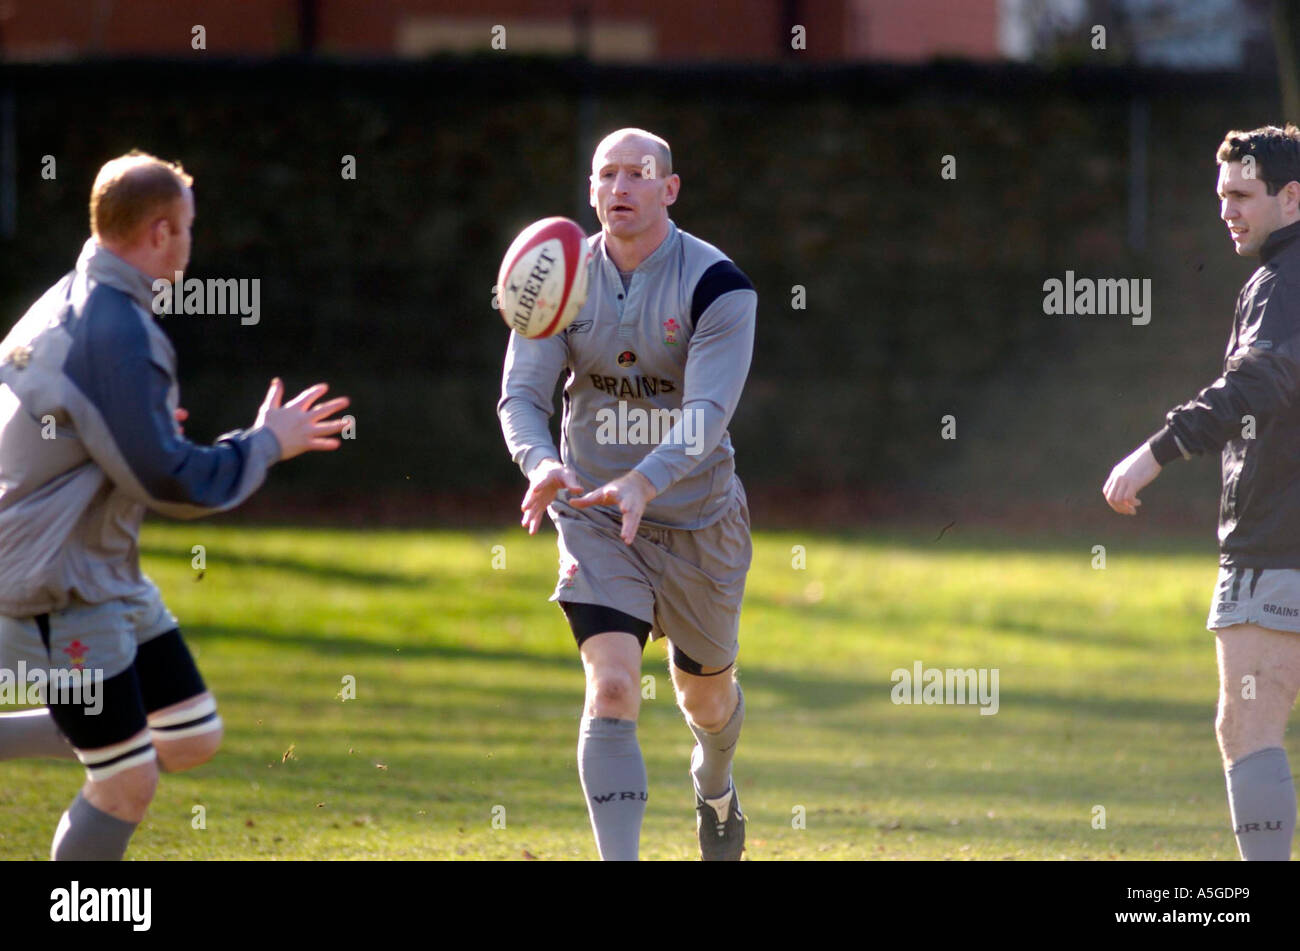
(0, 152, 347, 860)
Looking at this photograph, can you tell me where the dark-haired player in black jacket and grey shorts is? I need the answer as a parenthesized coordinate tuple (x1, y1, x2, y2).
(1102, 125, 1300, 860)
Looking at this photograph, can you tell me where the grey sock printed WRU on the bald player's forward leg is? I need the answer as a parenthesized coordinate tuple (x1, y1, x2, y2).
(577, 717, 649, 861)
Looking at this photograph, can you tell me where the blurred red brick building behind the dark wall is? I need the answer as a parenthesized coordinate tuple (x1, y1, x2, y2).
(0, 0, 1002, 62)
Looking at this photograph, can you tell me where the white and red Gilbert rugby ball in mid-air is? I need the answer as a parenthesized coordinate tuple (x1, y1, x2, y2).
(497, 218, 592, 339)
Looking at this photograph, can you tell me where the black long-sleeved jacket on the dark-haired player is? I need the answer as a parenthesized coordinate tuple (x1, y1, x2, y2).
(1149, 222, 1300, 568)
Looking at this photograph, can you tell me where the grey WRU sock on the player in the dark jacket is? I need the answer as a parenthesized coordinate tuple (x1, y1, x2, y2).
(1227, 746, 1296, 861)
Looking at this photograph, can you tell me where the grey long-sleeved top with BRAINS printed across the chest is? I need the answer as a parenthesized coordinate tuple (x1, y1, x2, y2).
(497, 221, 758, 529)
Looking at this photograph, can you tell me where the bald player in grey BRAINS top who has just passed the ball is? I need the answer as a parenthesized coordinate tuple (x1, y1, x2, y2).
(498, 129, 758, 860)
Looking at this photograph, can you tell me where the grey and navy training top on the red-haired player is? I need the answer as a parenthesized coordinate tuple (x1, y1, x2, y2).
(0, 239, 280, 617)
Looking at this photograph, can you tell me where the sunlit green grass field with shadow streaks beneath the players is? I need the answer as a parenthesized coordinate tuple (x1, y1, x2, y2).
(0, 522, 1236, 860)
